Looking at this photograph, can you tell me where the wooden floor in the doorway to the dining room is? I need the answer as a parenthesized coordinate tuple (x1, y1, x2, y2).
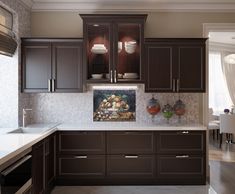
(209, 131, 235, 194)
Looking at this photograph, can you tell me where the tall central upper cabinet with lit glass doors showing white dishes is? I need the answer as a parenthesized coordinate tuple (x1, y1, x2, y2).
(80, 14, 147, 83)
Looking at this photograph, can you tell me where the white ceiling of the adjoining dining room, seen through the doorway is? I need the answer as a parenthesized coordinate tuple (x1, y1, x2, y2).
(209, 32, 235, 45)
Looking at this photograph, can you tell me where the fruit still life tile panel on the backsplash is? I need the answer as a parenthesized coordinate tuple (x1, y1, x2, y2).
(93, 90, 136, 121)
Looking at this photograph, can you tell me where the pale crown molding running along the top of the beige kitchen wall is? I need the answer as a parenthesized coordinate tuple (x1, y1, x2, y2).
(30, 0, 235, 13)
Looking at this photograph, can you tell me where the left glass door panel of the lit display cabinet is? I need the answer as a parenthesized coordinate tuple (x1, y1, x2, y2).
(86, 23, 111, 80)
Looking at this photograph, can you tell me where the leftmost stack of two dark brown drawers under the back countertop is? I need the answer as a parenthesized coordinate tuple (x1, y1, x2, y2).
(57, 131, 106, 185)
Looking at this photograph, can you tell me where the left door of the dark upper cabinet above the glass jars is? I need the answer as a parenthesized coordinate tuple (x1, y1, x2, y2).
(145, 44, 173, 92)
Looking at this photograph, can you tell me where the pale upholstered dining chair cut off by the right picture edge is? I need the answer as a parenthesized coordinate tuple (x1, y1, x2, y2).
(220, 114, 235, 147)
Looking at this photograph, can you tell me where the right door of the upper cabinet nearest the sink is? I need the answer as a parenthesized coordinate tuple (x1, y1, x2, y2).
(53, 42, 83, 92)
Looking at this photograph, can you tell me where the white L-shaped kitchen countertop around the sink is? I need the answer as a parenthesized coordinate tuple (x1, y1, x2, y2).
(0, 123, 206, 168)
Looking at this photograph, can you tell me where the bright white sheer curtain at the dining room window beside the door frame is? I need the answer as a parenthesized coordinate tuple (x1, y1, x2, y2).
(209, 51, 233, 114)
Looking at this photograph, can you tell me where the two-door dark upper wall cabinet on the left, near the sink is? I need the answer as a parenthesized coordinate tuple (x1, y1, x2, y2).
(22, 38, 83, 92)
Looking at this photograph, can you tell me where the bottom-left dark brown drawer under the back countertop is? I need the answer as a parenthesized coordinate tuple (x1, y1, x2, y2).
(58, 155, 105, 178)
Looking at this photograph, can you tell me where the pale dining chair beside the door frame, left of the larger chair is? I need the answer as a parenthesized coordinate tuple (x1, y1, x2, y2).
(207, 108, 220, 140)
